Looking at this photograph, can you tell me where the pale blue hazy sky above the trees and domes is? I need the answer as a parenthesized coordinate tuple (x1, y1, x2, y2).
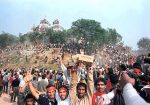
(0, 0, 150, 49)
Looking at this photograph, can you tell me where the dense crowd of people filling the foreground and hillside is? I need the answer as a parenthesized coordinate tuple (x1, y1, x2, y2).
(0, 42, 150, 105)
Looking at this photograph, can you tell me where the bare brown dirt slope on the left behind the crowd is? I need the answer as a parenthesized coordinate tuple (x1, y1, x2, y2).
(0, 48, 71, 70)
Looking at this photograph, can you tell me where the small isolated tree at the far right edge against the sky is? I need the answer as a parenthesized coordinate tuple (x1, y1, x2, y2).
(137, 37, 150, 50)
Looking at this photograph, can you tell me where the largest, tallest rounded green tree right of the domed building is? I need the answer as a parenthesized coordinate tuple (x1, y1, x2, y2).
(71, 19, 103, 53)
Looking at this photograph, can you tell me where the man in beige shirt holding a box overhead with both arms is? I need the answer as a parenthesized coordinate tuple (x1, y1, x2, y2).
(70, 62, 94, 105)
